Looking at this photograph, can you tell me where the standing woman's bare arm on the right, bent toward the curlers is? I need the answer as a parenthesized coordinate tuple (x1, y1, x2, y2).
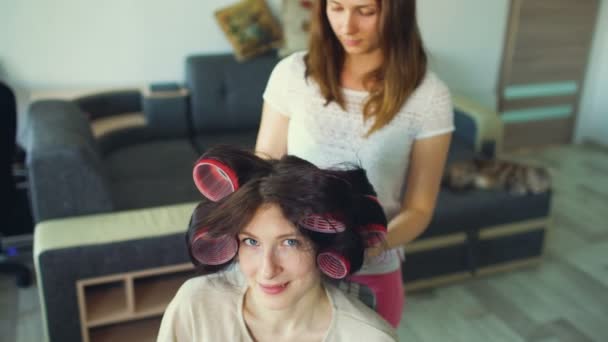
(369, 133, 452, 256)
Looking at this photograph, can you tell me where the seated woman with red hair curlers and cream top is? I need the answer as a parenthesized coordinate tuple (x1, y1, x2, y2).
(158, 147, 396, 341)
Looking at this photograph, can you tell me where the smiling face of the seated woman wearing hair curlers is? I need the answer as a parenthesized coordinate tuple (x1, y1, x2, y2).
(238, 204, 321, 310)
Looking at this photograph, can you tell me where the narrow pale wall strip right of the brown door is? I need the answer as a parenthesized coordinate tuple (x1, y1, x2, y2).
(575, 0, 608, 146)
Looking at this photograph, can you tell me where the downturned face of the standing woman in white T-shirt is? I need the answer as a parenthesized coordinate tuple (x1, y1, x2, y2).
(325, 0, 380, 55)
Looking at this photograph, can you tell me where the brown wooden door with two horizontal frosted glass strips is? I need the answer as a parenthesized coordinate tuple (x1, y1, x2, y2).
(498, 0, 599, 151)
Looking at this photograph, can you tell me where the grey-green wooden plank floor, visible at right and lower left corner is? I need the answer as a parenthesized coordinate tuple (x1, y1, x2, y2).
(0, 145, 608, 342)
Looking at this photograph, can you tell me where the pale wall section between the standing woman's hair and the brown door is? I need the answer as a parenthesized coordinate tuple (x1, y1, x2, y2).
(418, 0, 510, 109)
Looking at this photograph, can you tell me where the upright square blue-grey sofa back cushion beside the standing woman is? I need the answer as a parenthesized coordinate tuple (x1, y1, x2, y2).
(186, 52, 279, 134)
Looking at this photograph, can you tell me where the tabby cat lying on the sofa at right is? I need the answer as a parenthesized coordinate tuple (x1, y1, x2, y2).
(443, 158, 551, 195)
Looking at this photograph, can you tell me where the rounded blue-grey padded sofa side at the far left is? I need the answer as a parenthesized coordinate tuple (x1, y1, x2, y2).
(26, 100, 113, 222)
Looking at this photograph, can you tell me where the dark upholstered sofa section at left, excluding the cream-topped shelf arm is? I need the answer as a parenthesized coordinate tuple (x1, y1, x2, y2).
(26, 50, 277, 222)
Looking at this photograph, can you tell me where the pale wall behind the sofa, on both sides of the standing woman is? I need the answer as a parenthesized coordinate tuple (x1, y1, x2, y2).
(0, 0, 536, 144)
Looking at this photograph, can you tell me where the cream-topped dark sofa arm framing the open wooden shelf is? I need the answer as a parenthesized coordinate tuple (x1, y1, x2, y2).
(34, 203, 196, 341)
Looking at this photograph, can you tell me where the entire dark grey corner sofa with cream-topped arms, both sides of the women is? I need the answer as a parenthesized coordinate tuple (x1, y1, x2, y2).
(27, 54, 550, 341)
